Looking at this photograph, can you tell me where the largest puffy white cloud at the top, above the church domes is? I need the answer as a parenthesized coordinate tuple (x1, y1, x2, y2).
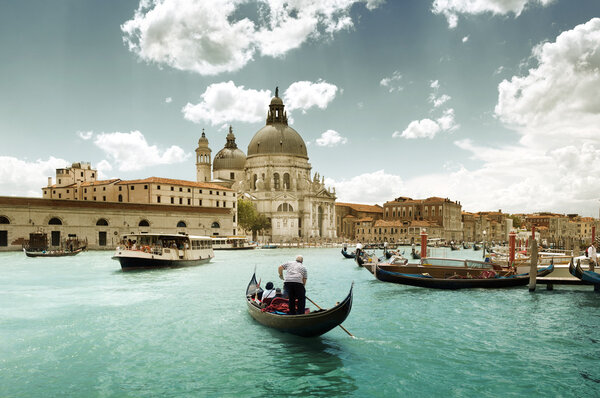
(121, 0, 383, 75)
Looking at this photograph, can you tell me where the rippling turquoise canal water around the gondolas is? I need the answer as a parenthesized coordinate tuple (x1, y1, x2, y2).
(0, 249, 600, 397)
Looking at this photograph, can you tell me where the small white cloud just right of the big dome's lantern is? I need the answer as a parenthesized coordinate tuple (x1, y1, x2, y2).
(282, 80, 338, 113)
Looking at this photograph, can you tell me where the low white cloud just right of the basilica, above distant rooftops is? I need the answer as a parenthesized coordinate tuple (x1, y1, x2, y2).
(325, 170, 404, 205)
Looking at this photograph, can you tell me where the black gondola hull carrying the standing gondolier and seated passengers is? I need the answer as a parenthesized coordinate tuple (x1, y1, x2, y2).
(246, 274, 354, 337)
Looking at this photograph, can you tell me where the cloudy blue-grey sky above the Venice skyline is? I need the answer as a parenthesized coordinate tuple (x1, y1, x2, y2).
(0, 0, 600, 217)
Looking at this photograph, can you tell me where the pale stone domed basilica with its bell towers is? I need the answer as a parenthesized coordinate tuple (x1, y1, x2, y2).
(196, 90, 336, 242)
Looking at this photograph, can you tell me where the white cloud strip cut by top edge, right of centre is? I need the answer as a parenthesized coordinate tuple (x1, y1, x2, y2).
(432, 0, 554, 29)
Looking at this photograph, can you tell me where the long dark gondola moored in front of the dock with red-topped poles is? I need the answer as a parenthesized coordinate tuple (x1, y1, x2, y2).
(375, 264, 554, 289)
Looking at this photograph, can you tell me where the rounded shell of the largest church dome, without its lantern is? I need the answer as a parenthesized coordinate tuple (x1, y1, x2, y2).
(248, 123, 308, 159)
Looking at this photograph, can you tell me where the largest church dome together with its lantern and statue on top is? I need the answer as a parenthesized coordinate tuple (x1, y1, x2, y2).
(248, 91, 308, 159)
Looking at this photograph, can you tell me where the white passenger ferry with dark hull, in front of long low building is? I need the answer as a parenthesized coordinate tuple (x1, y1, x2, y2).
(112, 233, 215, 271)
